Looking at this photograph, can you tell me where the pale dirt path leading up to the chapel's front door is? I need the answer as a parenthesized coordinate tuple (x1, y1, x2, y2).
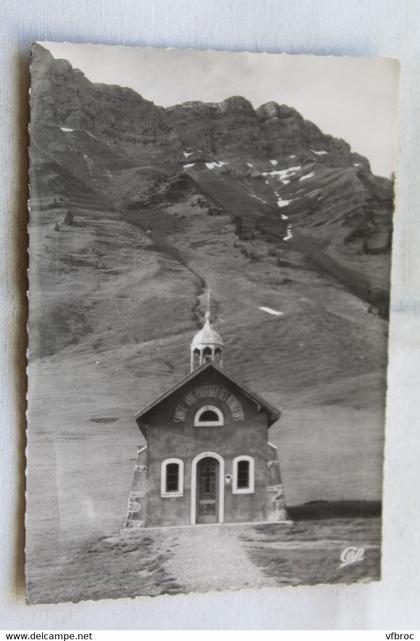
(156, 525, 275, 592)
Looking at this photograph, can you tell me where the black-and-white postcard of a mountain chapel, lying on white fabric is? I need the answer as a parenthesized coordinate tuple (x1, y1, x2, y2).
(25, 42, 399, 604)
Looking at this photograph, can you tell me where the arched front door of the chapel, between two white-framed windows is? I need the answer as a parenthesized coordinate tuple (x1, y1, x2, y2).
(196, 456, 220, 523)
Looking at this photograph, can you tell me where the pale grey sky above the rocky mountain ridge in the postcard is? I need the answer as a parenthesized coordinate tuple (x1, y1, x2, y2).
(41, 42, 399, 177)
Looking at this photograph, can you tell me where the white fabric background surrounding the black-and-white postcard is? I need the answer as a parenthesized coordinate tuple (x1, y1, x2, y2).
(0, 0, 420, 629)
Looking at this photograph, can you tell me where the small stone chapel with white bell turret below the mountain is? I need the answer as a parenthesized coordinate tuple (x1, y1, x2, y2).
(125, 311, 287, 528)
